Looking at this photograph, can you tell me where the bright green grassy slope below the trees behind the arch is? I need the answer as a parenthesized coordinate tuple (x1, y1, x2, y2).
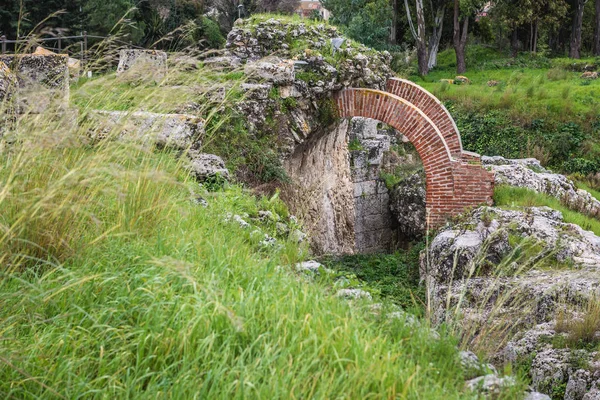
(412, 45, 600, 122)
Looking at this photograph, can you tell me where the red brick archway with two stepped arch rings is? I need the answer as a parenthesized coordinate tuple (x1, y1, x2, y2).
(335, 88, 494, 228)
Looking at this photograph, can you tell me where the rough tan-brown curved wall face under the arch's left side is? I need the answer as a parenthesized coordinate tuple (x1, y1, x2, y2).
(284, 121, 355, 254)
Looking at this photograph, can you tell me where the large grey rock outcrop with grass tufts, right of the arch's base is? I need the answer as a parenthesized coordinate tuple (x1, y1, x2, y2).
(421, 198, 600, 399)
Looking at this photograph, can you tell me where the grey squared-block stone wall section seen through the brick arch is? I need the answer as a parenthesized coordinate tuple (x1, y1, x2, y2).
(348, 117, 394, 253)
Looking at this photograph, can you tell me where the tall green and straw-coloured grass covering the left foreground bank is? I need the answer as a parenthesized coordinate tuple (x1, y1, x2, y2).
(0, 46, 519, 399)
